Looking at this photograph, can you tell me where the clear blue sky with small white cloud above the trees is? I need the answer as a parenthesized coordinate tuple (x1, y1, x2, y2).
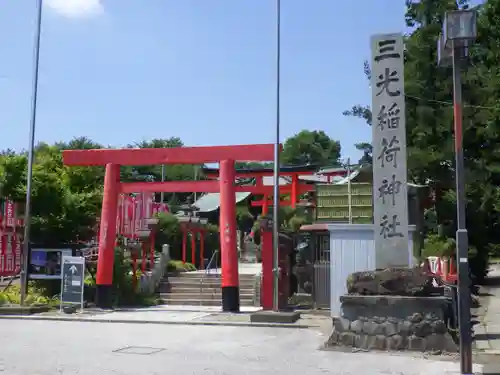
(0, 0, 405, 157)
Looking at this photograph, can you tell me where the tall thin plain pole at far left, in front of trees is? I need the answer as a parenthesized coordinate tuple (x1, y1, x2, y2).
(20, 0, 43, 305)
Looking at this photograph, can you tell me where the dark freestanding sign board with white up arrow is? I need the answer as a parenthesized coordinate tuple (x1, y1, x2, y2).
(61, 256, 85, 310)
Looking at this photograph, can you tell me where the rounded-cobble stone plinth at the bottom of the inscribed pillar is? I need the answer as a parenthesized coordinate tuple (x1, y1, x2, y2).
(326, 295, 458, 353)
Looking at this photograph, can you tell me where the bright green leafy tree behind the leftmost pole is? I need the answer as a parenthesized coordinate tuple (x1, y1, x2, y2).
(0, 143, 102, 246)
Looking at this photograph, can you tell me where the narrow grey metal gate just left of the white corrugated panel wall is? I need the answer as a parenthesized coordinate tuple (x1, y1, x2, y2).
(311, 232, 330, 309)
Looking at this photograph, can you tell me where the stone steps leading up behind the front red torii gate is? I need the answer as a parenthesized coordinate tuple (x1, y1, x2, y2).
(159, 272, 260, 306)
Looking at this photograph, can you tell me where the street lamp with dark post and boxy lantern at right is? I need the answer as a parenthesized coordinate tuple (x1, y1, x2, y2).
(438, 10, 477, 374)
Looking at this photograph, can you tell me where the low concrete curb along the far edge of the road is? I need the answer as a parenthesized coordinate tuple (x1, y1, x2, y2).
(0, 315, 315, 329)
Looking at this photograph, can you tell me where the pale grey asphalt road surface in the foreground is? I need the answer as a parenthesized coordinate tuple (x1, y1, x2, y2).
(0, 320, 472, 375)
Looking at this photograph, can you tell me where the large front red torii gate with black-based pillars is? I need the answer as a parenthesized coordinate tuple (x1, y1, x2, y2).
(63, 144, 274, 312)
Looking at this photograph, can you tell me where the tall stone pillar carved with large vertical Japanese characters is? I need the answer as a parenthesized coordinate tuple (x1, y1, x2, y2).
(371, 34, 409, 268)
